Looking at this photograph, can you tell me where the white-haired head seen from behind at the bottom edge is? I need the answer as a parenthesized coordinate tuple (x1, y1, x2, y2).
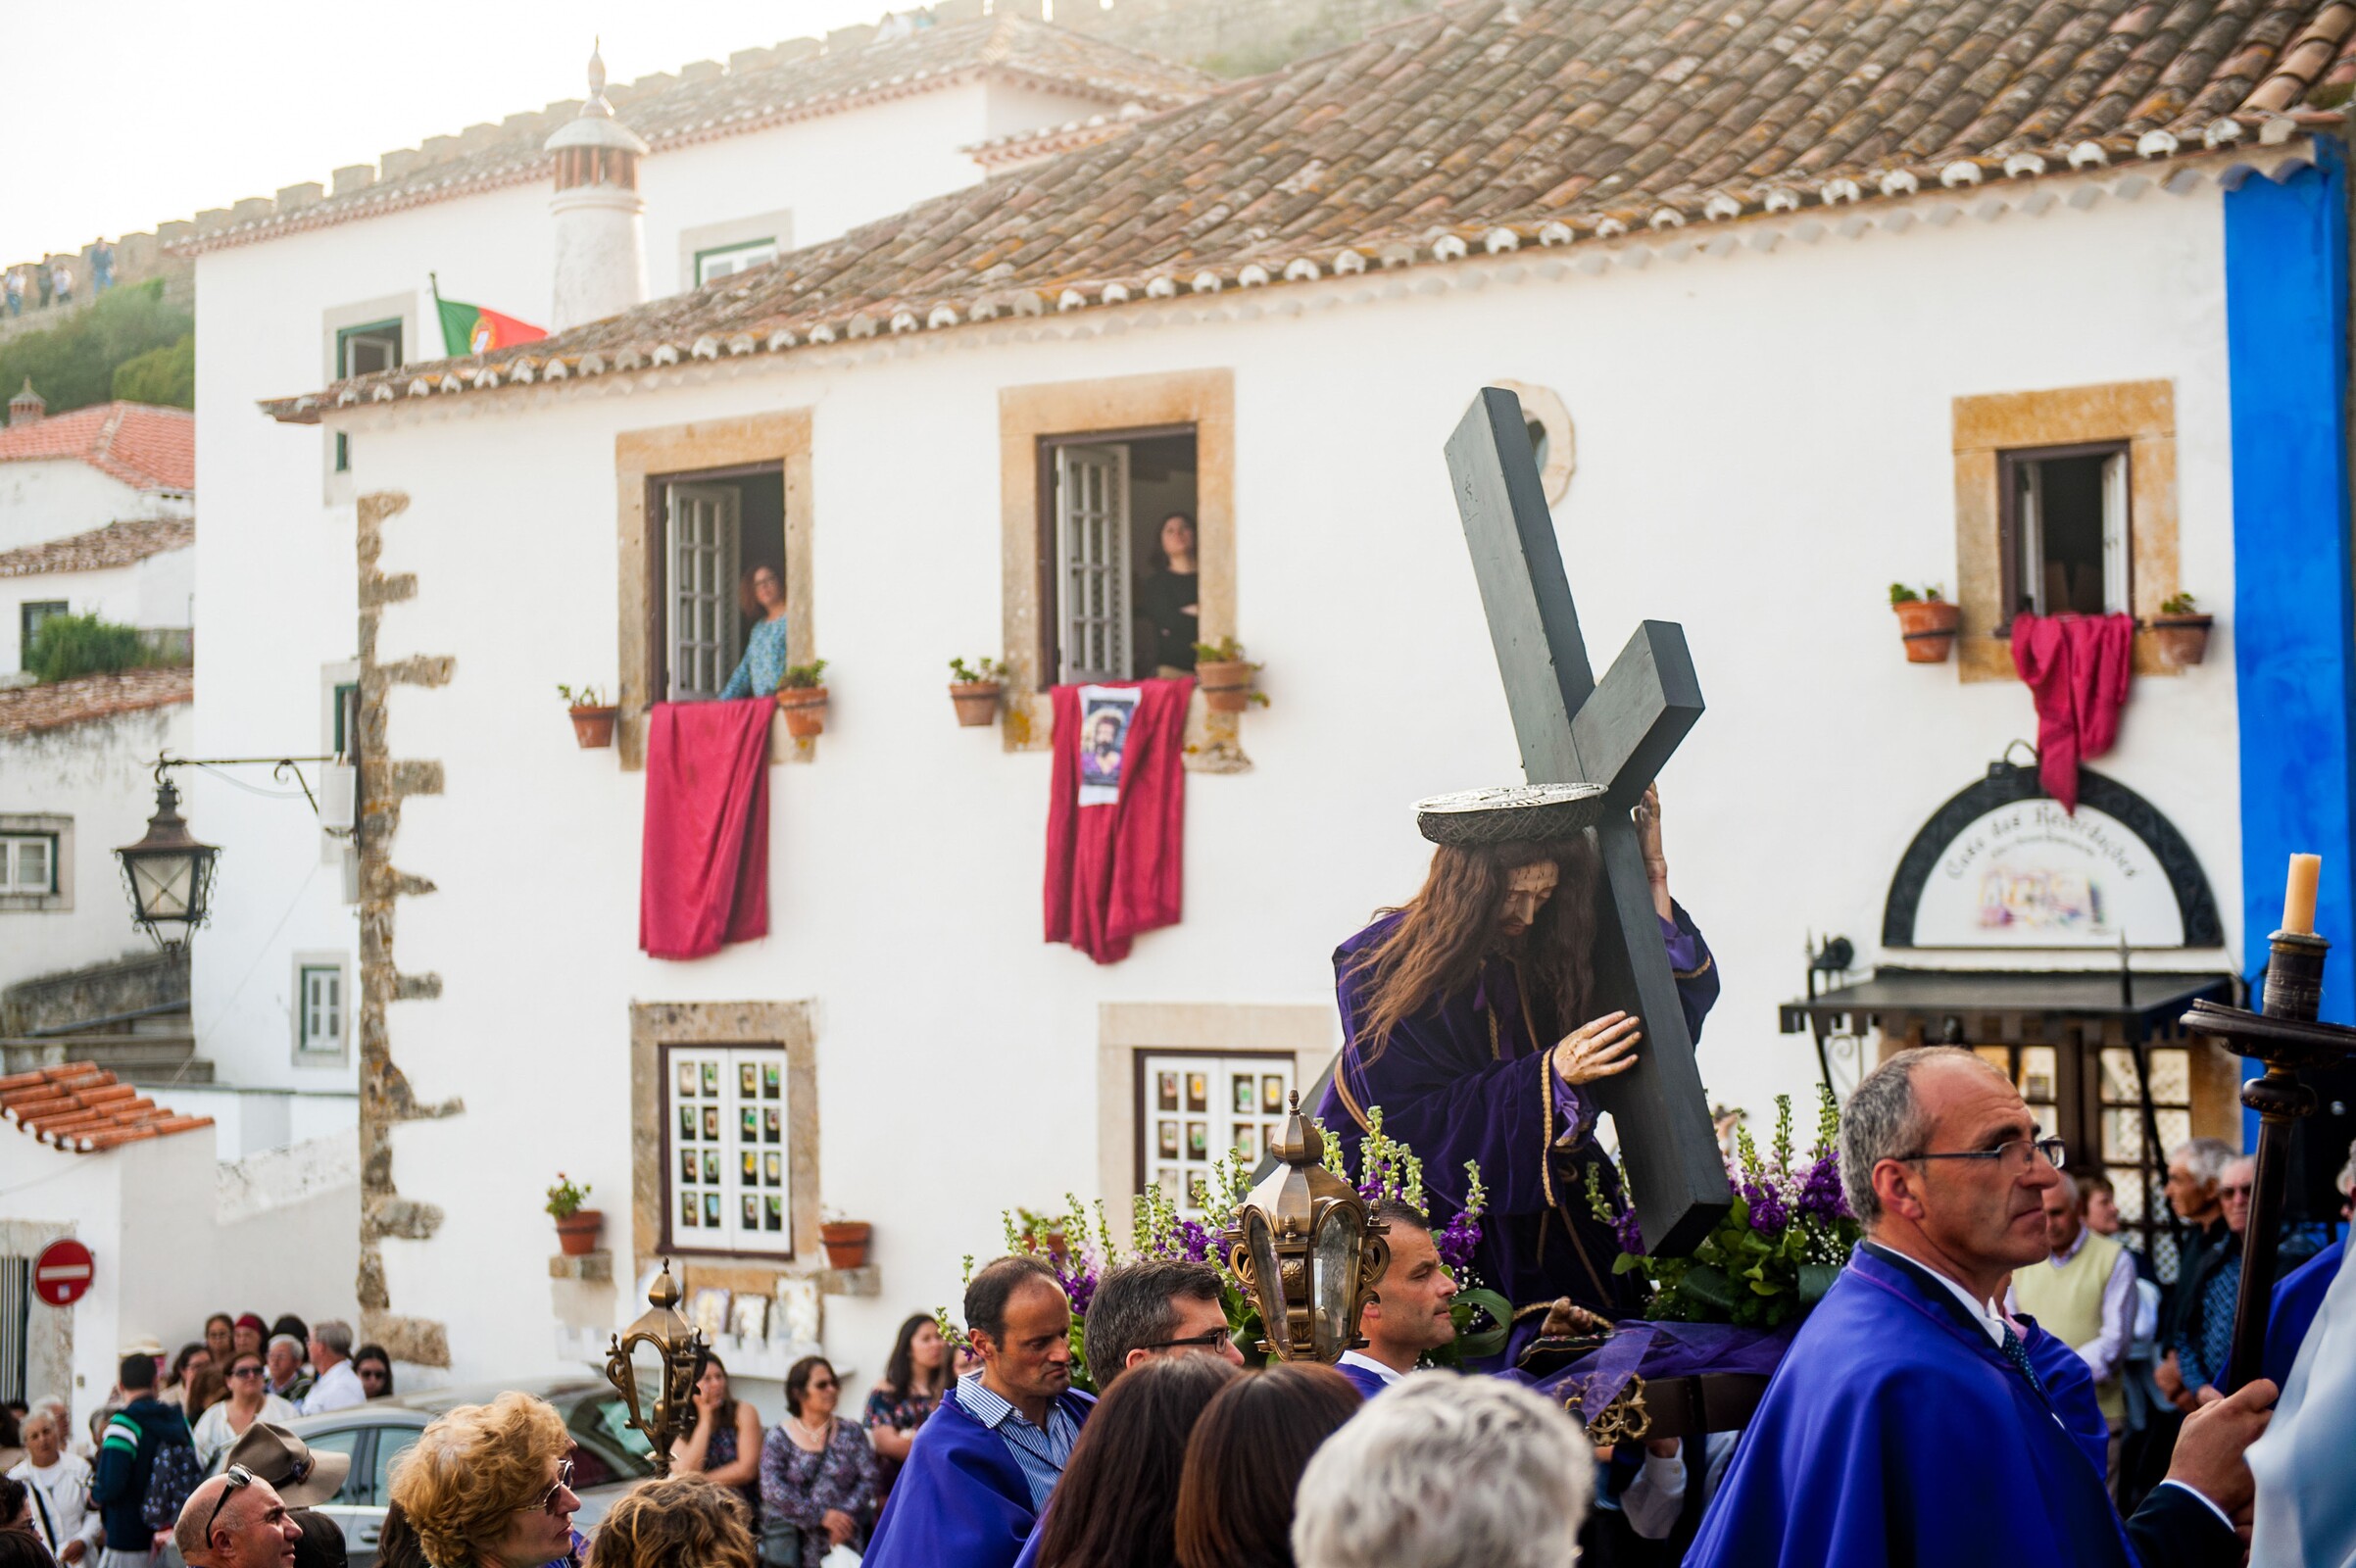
(1294, 1373, 1595, 1568)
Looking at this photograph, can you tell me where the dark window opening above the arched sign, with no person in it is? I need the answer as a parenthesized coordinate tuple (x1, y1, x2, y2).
(2002, 440, 2133, 614)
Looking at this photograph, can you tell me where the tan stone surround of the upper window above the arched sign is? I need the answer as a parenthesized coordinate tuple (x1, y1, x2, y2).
(1953, 381, 2182, 680)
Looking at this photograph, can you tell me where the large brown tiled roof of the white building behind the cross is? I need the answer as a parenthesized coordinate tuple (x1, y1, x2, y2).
(264, 0, 2356, 421)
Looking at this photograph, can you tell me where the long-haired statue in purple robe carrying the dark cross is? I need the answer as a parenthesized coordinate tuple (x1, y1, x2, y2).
(1317, 789, 1718, 1330)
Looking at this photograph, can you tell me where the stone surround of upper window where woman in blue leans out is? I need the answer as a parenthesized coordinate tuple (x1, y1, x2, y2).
(613, 408, 817, 772)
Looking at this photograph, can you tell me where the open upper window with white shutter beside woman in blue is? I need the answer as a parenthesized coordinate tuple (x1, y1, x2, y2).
(648, 464, 787, 702)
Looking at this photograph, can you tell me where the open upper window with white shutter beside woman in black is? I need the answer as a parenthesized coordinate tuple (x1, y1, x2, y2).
(1037, 423, 1200, 685)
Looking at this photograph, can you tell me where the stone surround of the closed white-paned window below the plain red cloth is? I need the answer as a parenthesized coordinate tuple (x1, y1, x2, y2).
(629, 1001, 824, 1295)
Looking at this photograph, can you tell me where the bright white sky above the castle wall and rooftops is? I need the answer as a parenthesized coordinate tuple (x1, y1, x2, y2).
(0, 0, 937, 264)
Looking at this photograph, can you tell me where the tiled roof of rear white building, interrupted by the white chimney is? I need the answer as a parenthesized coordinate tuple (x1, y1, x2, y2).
(174, 17, 1218, 254)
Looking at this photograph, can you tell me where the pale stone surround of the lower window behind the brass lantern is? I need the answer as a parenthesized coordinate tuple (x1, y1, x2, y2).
(1096, 1003, 1341, 1236)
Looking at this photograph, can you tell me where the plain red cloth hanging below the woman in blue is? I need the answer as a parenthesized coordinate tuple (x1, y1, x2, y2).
(638, 697, 777, 958)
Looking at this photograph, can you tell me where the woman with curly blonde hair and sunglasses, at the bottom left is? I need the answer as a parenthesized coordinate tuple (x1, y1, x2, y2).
(393, 1394, 582, 1568)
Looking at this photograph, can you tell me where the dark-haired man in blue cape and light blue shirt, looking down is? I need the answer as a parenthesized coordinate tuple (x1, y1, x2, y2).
(864, 1254, 1096, 1568)
